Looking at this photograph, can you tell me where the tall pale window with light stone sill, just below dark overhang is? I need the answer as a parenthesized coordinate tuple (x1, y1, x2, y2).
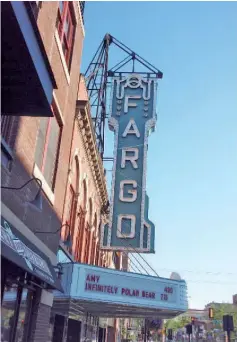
(35, 108, 61, 190)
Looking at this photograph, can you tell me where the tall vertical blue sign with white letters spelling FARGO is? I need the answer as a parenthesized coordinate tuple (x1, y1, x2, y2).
(101, 74, 157, 253)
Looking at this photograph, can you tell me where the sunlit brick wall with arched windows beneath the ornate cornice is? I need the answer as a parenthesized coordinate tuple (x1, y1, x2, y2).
(62, 78, 112, 267)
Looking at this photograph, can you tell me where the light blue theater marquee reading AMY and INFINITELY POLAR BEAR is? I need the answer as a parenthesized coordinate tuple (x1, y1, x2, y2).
(54, 263, 188, 318)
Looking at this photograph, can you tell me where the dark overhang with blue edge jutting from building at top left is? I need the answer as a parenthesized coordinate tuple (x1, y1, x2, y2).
(1, 1, 56, 116)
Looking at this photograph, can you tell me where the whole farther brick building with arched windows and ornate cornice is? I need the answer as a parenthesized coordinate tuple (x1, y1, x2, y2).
(51, 75, 114, 342)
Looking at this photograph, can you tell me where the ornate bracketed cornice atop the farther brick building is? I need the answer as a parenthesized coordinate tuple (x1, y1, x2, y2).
(76, 100, 108, 206)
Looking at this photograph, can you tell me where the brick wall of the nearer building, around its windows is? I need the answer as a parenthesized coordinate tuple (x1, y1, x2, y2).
(1, 1, 84, 253)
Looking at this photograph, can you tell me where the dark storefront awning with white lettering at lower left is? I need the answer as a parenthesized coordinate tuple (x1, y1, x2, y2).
(1, 216, 63, 291)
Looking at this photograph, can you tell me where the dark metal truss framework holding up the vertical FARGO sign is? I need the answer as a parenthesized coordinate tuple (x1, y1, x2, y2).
(85, 33, 163, 160)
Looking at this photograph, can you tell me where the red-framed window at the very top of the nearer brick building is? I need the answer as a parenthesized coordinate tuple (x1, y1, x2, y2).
(57, 1, 76, 70)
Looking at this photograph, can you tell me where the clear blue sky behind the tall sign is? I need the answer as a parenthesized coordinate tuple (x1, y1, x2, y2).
(82, 2, 237, 308)
